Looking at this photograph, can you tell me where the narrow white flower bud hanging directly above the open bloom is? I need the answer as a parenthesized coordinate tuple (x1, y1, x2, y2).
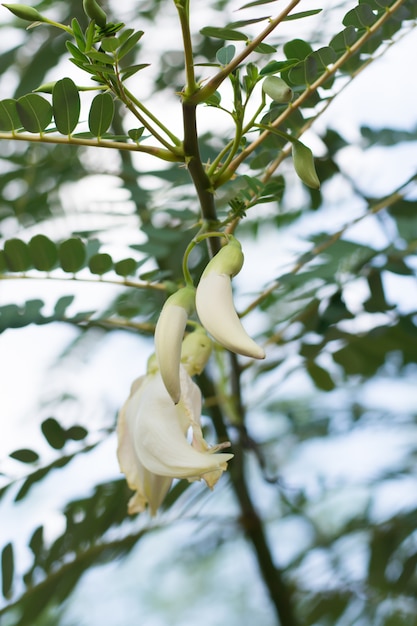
(155, 287, 195, 404)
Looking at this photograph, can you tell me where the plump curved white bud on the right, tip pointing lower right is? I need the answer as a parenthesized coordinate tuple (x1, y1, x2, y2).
(196, 237, 265, 359)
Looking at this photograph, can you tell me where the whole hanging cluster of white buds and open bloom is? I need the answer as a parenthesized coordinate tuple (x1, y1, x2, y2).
(118, 237, 265, 515)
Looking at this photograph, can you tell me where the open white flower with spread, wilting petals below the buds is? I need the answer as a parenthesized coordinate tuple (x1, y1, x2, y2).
(118, 366, 233, 515)
